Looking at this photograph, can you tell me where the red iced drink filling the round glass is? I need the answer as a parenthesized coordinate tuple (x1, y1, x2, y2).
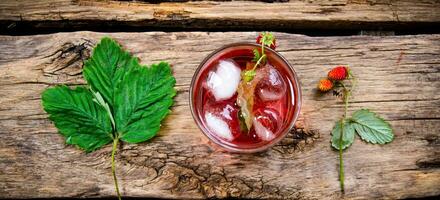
(190, 43, 301, 152)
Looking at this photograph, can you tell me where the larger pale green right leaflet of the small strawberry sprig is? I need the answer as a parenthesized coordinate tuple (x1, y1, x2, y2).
(351, 109, 394, 144)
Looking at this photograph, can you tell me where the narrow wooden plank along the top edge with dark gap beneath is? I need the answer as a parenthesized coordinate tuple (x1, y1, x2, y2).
(0, 0, 440, 31)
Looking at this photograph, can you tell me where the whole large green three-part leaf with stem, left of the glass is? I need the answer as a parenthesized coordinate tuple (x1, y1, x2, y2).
(42, 37, 176, 199)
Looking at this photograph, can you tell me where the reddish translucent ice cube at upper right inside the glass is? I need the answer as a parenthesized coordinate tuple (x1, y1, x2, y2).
(257, 65, 286, 101)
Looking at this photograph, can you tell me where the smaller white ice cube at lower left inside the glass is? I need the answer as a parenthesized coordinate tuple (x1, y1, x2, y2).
(205, 112, 234, 141)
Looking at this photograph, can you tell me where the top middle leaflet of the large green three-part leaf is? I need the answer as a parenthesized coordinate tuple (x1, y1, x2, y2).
(83, 37, 140, 107)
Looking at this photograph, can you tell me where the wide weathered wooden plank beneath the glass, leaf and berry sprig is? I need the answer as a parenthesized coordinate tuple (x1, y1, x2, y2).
(0, 32, 440, 199)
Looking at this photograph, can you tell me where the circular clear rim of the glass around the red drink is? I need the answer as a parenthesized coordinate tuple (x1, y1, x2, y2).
(189, 42, 302, 153)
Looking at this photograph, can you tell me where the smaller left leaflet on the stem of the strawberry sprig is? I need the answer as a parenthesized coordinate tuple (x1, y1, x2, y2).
(331, 120, 354, 150)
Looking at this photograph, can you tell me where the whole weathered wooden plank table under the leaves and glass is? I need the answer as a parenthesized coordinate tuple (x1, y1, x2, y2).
(0, 0, 440, 199)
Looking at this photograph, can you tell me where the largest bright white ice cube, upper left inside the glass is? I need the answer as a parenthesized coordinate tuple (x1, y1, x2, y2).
(207, 60, 241, 101)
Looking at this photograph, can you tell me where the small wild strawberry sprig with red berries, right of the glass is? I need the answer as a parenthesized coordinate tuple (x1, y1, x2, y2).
(318, 66, 394, 192)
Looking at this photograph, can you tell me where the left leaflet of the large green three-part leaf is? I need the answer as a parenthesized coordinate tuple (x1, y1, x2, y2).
(42, 86, 112, 152)
